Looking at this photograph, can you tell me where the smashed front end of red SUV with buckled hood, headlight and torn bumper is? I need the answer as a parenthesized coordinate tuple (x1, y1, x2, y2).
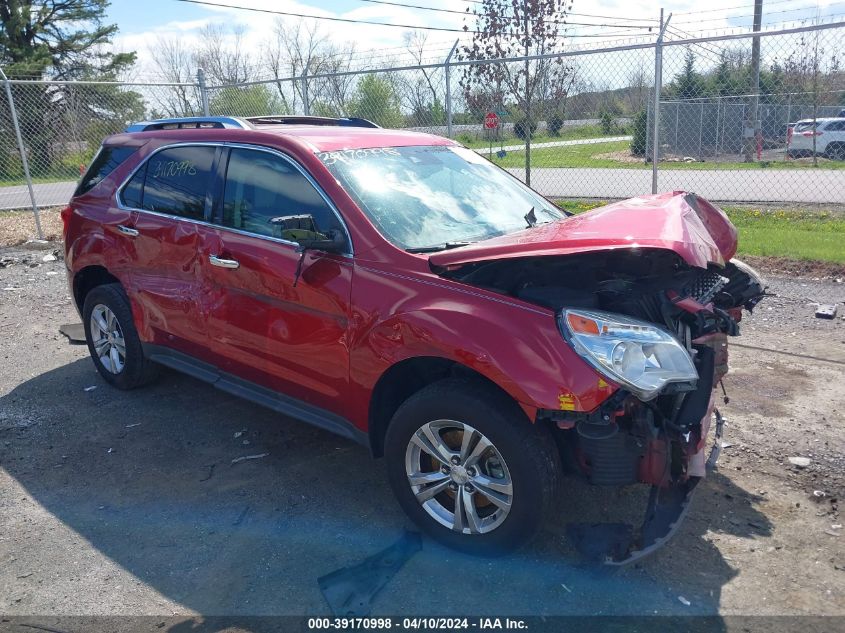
(432, 192, 765, 565)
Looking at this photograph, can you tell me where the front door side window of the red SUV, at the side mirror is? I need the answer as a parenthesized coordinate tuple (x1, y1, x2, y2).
(220, 148, 348, 241)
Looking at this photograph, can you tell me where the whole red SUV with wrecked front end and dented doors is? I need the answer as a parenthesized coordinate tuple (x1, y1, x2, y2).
(63, 117, 764, 563)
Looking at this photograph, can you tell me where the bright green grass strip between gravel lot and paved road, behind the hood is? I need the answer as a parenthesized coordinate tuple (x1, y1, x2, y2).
(558, 200, 845, 264)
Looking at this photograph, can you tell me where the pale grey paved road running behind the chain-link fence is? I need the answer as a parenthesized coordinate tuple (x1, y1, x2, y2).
(0, 162, 845, 210)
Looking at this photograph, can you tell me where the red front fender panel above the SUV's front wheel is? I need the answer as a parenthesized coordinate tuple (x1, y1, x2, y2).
(350, 262, 617, 419)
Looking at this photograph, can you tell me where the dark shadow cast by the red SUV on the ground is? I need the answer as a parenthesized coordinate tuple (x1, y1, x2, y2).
(0, 358, 772, 631)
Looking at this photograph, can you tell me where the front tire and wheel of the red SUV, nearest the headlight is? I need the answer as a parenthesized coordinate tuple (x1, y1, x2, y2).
(385, 379, 561, 555)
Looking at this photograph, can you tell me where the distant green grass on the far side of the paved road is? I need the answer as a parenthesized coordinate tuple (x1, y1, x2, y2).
(484, 137, 845, 171)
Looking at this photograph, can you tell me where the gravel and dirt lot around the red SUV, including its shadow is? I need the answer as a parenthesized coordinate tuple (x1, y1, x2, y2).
(0, 243, 845, 631)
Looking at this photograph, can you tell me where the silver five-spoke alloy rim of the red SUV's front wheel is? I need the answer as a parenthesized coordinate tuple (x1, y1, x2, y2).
(405, 420, 513, 534)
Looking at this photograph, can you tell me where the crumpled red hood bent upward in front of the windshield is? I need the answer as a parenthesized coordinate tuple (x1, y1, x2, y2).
(429, 191, 737, 269)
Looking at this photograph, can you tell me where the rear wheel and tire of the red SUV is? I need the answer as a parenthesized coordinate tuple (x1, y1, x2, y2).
(82, 284, 157, 389)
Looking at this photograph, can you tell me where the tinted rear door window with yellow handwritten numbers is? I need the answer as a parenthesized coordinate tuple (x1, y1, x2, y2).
(121, 146, 215, 220)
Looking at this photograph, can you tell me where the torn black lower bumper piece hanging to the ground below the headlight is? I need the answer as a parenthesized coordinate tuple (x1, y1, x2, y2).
(568, 409, 725, 567)
